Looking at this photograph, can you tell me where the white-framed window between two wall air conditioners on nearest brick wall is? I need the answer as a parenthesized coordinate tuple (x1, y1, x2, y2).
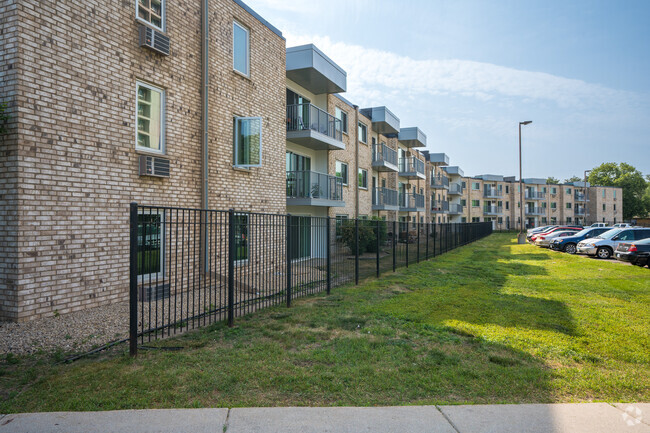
(135, 83, 165, 153)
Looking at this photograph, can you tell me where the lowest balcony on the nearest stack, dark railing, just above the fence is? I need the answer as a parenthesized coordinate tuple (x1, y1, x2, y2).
(287, 171, 345, 207)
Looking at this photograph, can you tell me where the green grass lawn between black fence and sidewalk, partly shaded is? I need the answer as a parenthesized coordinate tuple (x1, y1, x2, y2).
(0, 234, 650, 413)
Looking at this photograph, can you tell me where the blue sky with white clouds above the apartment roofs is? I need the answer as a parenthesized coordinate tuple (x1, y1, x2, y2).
(245, 0, 650, 180)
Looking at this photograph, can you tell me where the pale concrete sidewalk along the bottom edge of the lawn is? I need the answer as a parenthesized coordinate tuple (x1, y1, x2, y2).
(0, 403, 650, 433)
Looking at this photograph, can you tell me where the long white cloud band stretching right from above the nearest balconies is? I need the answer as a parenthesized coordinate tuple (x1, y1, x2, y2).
(284, 34, 638, 109)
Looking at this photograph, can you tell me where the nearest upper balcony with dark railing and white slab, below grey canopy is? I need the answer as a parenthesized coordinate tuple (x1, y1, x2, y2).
(287, 104, 345, 150)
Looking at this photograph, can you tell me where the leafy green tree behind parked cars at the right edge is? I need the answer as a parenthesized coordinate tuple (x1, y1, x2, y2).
(589, 162, 650, 220)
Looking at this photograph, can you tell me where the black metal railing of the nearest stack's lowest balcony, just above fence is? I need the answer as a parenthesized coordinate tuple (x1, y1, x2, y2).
(287, 171, 343, 200)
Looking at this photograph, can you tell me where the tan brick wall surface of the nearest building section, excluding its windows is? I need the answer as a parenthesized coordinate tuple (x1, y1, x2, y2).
(5, 0, 286, 320)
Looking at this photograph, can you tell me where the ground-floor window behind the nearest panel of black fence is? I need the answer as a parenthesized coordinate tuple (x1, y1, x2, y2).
(137, 210, 164, 280)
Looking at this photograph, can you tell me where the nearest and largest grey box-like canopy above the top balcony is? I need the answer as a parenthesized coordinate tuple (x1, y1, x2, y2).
(286, 44, 347, 95)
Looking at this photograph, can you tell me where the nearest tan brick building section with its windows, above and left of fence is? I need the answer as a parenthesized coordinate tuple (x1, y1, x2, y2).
(0, 0, 286, 321)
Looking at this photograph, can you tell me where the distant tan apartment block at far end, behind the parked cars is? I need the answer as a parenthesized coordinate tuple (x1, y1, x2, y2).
(463, 174, 623, 230)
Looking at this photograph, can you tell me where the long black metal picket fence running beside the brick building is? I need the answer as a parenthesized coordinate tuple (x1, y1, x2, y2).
(130, 203, 492, 355)
